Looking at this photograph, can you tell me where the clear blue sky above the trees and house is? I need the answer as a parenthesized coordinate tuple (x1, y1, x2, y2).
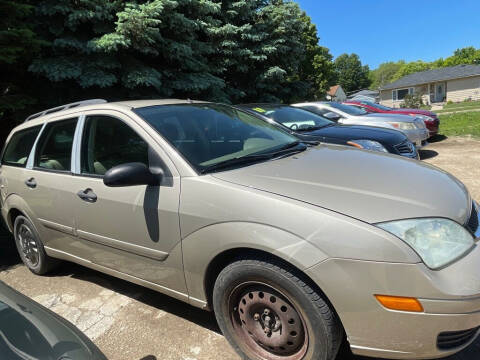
(296, 0, 480, 69)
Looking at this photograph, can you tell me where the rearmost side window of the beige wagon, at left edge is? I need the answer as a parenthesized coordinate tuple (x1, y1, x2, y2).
(2, 125, 42, 167)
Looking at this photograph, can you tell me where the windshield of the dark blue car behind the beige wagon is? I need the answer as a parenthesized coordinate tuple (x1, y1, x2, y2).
(249, 105, 335, 131)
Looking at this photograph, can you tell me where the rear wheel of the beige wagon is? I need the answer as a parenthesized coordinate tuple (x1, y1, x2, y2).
(13, 215, 58, 275)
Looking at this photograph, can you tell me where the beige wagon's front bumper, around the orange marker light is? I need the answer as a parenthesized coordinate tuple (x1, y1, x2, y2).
(307, 246, 480, 359)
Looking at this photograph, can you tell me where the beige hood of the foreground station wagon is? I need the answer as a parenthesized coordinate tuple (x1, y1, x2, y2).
(212, 145, 471, 224)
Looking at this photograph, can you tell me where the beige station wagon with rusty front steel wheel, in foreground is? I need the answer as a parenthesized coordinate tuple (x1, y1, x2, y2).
(0, 100, 480, 360)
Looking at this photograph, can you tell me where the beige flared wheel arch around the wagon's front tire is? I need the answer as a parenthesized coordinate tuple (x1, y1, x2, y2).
(182, 222, 328, 306)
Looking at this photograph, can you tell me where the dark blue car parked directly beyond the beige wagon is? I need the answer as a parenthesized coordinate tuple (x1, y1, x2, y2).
(237, 104, 418, 159)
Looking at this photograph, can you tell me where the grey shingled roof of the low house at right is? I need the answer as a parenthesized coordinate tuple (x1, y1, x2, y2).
(380, 65, 480, 90)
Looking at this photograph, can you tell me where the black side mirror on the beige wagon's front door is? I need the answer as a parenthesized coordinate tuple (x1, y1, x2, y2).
(103, 162, 163, 187)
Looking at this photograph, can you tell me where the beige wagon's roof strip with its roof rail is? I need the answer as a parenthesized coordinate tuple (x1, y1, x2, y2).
(13, 99, 209, 131)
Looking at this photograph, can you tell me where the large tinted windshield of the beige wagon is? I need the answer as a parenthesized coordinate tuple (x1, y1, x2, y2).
(134, 103, 298, 172)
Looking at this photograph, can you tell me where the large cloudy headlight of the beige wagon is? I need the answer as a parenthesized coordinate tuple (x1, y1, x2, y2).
(377, 218, 475, 269)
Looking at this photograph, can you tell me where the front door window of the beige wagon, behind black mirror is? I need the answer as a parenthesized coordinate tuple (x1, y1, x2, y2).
(81, 116, 148, 176)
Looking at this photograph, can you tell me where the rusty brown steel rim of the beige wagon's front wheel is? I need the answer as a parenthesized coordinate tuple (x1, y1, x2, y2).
(229, 282, 308, 360)
